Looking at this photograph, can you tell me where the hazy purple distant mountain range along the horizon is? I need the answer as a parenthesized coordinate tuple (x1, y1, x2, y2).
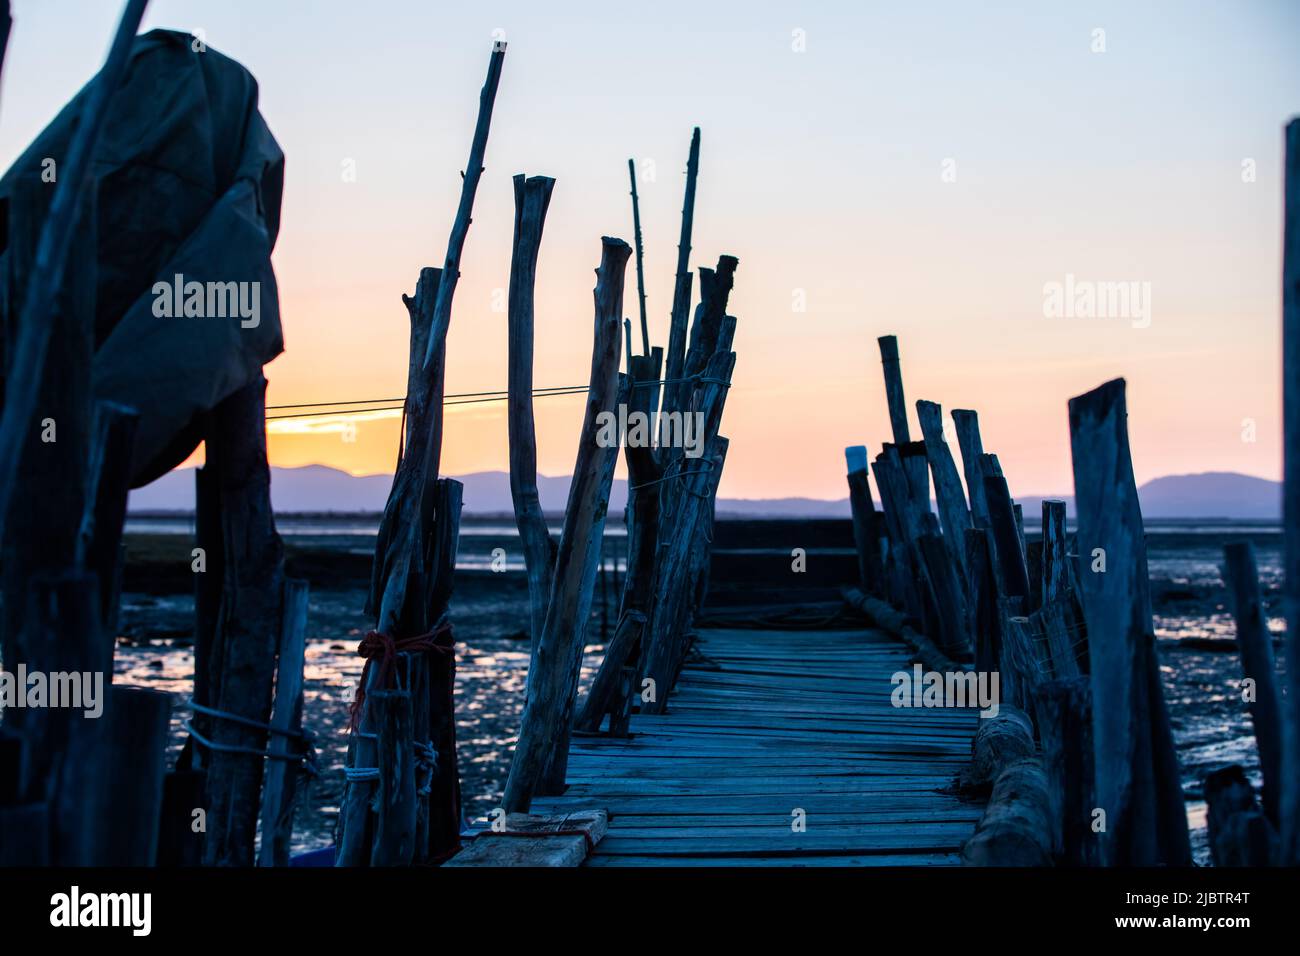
(129, 464, 1282, 520)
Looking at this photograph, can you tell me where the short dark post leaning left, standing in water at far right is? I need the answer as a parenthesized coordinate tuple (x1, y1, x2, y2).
(1223, 541, 1283, 825)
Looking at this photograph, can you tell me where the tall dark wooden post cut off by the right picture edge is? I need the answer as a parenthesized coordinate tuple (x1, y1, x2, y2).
(1279, 118, 1300, 866)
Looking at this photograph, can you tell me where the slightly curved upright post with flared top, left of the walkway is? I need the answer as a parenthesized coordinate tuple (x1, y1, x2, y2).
(507, 176, 555, 650)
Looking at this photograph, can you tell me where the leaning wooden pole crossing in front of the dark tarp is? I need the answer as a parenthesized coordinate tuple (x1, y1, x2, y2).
(0, 0, 148, 537)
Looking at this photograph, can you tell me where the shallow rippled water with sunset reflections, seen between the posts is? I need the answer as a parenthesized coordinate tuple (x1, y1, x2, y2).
(101, 523, 1282, 862)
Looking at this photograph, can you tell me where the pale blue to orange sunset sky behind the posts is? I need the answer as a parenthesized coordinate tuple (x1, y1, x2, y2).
(0, 0, 1300, 498)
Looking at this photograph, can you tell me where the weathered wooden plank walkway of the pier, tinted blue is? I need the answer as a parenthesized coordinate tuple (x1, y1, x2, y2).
(532, 630, 983, 866)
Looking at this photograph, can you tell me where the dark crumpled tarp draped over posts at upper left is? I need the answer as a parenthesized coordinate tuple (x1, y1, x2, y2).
(0, 30, 285, 486)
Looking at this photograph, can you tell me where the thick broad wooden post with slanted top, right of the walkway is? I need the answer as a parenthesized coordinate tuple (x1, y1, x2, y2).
(1066, 378, 1191, 866)
